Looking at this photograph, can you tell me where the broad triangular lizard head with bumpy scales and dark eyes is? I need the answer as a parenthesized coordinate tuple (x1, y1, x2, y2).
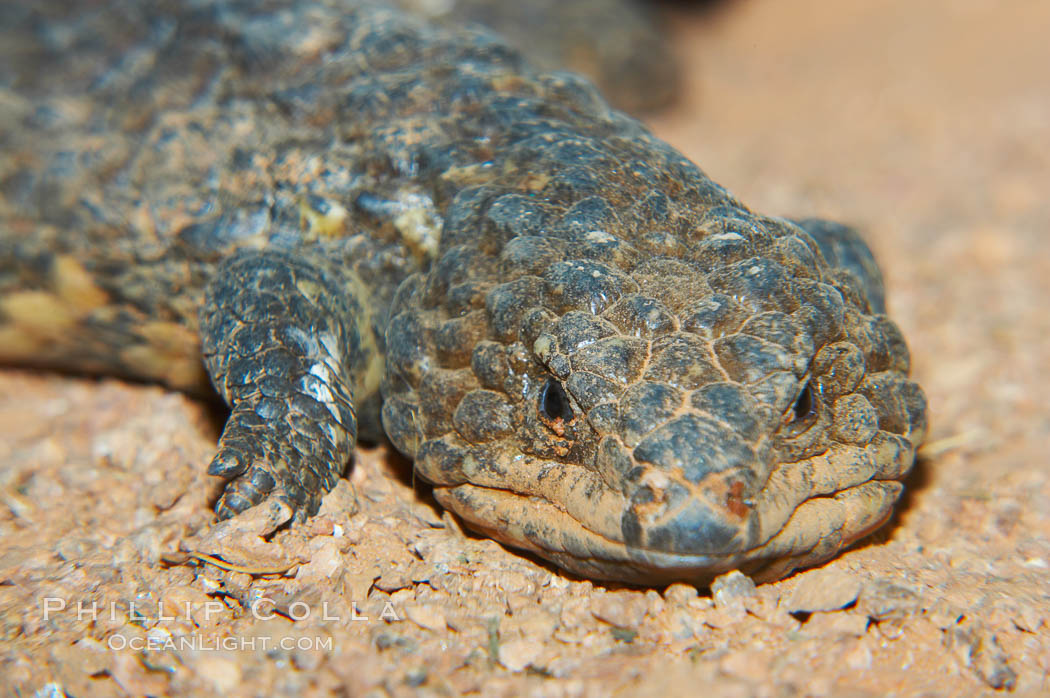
(383, 177, 925, 584)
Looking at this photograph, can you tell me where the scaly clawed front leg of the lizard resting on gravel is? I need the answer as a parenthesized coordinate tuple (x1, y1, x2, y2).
(200, 250, 368, 521)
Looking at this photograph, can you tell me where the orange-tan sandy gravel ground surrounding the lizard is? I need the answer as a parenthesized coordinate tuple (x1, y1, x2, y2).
(0, 0, 1050, 696)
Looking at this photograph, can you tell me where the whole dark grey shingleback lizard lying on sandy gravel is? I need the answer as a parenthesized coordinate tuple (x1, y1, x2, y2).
(0, 0, 926, 584)
